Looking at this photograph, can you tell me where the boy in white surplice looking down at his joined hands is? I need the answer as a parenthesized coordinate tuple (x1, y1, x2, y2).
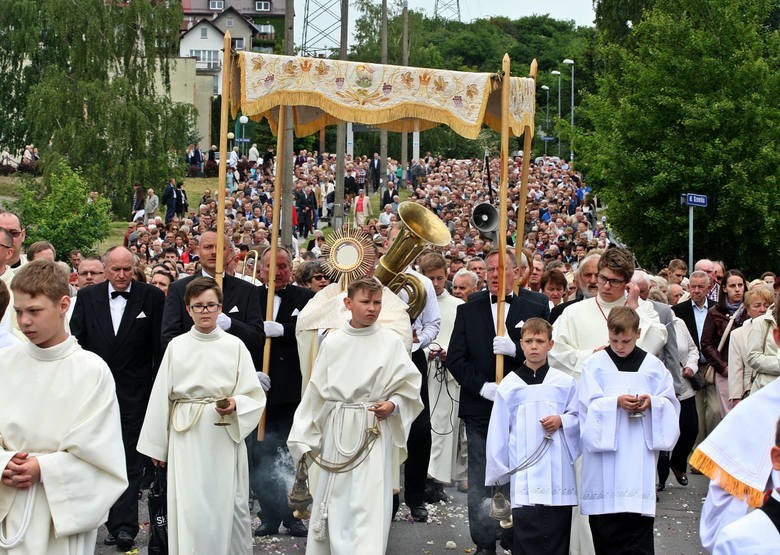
(578, 307, 680, 555)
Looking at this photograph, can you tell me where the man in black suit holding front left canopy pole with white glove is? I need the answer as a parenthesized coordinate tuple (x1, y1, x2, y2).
(249, 249, 314, 537)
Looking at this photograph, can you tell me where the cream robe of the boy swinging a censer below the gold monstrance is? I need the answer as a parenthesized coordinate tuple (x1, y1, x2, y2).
(287, 323, 423, 555)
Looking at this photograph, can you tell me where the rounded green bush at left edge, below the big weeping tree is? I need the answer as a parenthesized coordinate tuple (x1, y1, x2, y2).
(12, 156, 111, 260)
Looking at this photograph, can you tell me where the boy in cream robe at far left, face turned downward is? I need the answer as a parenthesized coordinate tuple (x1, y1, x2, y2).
(0, 259, 127, 555)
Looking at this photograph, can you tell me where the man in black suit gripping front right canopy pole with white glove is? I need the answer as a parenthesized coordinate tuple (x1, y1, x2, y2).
(447, 251, 550, 555)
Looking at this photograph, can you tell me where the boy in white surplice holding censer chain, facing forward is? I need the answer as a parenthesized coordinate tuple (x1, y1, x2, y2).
(485, 318, 580, 555)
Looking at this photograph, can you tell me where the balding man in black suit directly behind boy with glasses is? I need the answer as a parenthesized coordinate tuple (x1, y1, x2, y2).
(162, 231, 265, 370)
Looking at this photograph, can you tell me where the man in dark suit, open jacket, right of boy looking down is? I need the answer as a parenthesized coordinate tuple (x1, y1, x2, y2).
(669, 270, 720, 472)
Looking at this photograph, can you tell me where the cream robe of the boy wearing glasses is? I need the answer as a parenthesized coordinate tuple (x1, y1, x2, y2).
(138, 327, 265, 555)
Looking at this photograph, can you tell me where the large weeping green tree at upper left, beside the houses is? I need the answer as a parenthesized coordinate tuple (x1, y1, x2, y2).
(0, 0, 194, 212)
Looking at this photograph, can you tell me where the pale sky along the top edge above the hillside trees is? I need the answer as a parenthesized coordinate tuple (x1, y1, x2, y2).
(295, 0, 596, 53)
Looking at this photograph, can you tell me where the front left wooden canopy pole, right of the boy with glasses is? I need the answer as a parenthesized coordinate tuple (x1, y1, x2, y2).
(257, 106, 287, 441)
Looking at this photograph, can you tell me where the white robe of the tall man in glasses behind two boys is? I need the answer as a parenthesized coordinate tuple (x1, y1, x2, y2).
(549, 297, 667, 378)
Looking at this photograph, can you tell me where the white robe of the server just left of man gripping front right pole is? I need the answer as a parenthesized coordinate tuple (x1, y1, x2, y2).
(425, 291, 463, 484)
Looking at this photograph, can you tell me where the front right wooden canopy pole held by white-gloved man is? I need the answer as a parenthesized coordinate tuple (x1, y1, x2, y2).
(496, 54, 510, 384)
